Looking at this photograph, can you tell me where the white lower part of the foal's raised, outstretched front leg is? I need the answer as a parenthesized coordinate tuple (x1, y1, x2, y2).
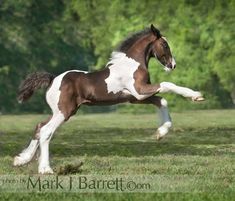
(159, 82, 202, 98)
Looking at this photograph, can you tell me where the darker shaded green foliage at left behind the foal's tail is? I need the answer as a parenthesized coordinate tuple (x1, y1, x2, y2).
(0, 0, 92, 113)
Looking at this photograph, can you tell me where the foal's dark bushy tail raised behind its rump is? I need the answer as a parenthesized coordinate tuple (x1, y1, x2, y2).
(17, 72, 55, 103)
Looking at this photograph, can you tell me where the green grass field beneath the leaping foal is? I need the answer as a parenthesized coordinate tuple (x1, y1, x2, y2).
(0, 110, 235, 200)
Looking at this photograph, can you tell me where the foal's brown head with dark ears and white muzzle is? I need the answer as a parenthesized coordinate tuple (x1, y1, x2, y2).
(151, 25, 176, 71)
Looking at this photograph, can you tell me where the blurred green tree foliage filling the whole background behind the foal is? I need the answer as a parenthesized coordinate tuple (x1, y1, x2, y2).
(0, 0, 235, 113)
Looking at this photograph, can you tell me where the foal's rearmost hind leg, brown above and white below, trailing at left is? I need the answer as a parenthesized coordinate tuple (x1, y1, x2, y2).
(13, 117, 51, 166)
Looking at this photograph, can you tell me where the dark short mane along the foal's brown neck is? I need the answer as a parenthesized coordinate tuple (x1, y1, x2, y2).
(117, 28, 151, 52)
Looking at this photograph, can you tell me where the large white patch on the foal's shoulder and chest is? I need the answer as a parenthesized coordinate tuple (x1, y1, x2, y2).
(105, 52, 151, 100)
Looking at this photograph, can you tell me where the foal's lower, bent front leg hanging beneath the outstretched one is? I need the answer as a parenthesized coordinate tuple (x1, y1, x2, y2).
(131, 96, 172, 140)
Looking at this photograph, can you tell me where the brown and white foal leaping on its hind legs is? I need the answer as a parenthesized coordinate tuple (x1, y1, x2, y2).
(13, 25, 204, 174)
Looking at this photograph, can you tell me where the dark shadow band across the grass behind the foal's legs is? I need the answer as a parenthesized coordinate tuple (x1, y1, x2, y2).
(0, 127, 235, 157)
